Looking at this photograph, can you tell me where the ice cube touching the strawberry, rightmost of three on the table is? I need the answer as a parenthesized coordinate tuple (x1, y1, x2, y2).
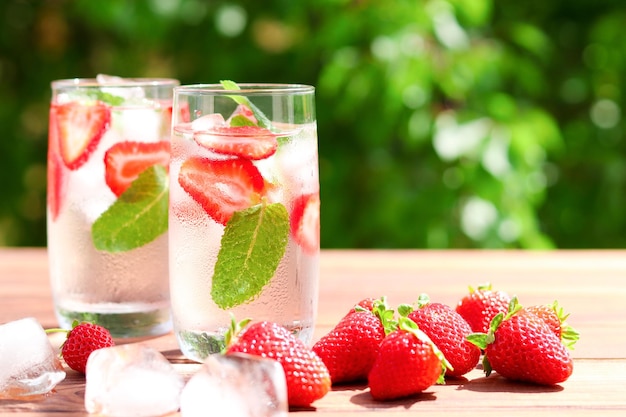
(180, 353, 289, 417)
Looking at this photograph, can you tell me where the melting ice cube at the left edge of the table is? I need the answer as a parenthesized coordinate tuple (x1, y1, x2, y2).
(0, 317, 65, 399)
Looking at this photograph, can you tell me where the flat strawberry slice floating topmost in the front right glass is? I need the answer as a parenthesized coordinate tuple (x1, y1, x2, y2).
(194, 126, 278, 160)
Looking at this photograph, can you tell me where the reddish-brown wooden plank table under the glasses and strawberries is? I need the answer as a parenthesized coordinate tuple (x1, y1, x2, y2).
(0, 249, 626, 416)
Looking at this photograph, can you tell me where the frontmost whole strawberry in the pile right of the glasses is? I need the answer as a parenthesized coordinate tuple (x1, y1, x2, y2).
(368, 317, 446, 401)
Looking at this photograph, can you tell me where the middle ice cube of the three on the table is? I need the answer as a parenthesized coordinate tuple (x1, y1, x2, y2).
(85, 343, 185, 417)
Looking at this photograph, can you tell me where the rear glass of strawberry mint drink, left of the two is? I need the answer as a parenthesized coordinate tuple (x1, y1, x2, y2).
(47, 76, 178, 338)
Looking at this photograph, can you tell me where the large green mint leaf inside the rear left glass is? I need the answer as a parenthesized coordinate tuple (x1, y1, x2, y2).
(91, 165, 169, 252)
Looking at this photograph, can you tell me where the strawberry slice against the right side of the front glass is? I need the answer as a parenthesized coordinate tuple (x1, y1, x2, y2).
(289, 193, 320, 254)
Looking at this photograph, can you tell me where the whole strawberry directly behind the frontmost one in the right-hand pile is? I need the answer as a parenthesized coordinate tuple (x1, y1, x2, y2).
(407, 295, 480, 377)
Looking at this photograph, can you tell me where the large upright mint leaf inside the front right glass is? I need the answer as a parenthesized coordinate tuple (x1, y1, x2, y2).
(211, 203, 289, 310)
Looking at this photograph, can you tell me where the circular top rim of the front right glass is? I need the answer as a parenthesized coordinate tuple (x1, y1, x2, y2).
(174, 83, 315, 95)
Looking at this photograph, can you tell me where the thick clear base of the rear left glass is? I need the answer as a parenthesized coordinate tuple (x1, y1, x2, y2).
(56, 308, 172, 339)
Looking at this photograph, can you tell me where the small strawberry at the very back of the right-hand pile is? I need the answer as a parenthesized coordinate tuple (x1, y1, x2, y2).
(456, 284, 511, 333)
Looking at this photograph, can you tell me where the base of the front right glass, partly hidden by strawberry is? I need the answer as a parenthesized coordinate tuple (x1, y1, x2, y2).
(175, 324, 313, 362)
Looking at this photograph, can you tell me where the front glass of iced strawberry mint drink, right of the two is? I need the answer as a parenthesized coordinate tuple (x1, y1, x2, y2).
(169, 81, 320, 361)
